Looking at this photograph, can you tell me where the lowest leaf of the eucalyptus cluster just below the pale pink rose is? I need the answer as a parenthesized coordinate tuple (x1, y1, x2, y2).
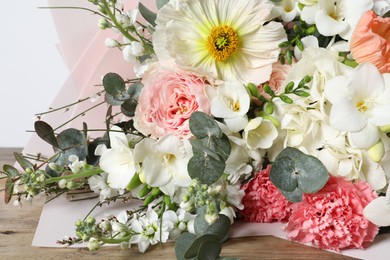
(187, 153, 225, 185)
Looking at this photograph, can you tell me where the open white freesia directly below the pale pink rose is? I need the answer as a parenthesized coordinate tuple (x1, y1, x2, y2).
(135, 135, 192, 196)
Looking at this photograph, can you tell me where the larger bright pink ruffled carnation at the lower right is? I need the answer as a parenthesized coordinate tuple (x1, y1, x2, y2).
(285, 176, 379, 251)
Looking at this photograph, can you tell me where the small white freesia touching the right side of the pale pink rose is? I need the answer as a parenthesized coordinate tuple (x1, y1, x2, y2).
(210, 81, 250, 132)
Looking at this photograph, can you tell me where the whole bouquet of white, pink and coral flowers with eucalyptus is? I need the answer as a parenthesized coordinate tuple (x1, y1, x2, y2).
(2, 0, 390, 259)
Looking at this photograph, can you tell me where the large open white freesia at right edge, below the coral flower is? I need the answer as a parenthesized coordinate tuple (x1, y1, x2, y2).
(325, 63, 390, 149)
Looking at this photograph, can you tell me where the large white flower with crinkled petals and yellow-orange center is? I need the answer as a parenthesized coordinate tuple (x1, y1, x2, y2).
(153, 0, 286, 83)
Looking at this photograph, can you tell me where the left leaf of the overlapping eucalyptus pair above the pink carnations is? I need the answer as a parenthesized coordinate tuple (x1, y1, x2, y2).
(269, 156, 298, 191)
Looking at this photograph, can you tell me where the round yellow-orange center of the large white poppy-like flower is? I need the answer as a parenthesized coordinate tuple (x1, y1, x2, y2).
(206, 25, 239, 61)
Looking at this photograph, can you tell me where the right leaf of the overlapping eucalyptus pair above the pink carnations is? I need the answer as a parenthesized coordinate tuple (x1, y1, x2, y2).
(295, 155, 329, 193)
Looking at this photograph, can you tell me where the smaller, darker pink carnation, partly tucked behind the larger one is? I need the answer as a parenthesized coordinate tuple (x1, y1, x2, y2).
(241, 165, 291, 223)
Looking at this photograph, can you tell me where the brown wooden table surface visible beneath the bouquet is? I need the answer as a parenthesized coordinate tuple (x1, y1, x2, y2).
(0, 148, 353, 260)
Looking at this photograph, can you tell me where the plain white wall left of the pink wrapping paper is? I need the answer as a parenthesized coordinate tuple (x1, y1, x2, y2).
(0, 0, 68, 147)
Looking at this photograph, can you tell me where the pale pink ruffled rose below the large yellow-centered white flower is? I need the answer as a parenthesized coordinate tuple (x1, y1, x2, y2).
(134, 69, 210, 139)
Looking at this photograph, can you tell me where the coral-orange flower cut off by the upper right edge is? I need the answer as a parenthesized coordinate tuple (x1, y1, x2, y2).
(350, 11, 390, 73)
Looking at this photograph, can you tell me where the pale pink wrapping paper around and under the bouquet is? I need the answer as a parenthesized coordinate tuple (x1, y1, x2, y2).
(23, 0, 390, 259)
